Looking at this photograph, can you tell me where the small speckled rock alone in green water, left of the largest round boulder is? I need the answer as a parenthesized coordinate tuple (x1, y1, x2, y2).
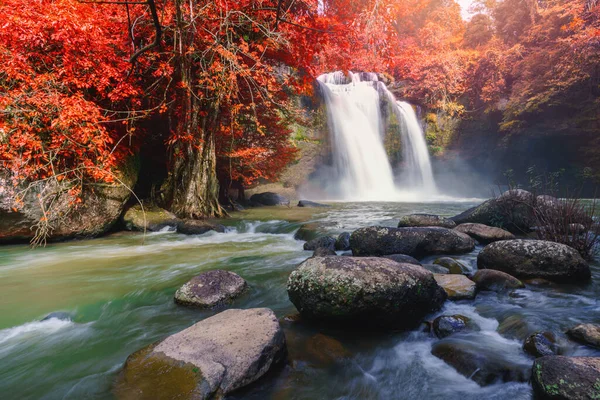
(175, 269, 248, 308)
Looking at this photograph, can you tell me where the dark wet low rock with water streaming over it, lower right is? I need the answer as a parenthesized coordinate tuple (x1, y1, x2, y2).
(431, 341, 529, 386)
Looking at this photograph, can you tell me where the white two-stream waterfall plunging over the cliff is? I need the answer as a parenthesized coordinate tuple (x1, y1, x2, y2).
(318, 71, 436, 201)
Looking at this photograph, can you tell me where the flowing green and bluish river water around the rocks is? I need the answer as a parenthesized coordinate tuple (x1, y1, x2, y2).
(0, 202, 600, 400)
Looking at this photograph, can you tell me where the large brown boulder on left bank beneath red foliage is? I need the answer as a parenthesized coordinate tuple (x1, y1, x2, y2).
(0, 158, 138, 243)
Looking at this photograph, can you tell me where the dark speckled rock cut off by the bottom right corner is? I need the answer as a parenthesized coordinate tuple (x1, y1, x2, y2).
(531, 356, 600, 400)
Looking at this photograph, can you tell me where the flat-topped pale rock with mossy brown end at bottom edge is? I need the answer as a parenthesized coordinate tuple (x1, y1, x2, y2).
(115, 308, 286, 400)
